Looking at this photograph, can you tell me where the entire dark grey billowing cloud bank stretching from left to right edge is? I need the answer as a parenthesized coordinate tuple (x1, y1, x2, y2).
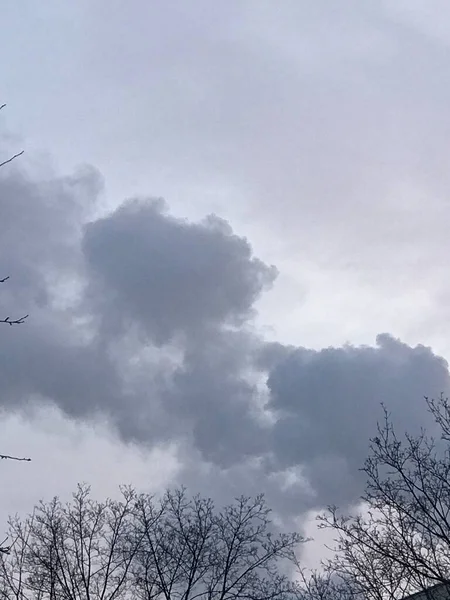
(0, 159, 449, 516)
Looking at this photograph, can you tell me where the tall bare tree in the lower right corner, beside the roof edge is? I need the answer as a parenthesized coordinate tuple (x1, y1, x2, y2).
(319, 396, 450, 600)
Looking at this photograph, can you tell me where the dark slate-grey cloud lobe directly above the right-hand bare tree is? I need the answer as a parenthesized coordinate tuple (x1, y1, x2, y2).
(169, 334, 450, 526)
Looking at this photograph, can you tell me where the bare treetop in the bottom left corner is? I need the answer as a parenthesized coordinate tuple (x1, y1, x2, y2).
(0, 486, 137, 600)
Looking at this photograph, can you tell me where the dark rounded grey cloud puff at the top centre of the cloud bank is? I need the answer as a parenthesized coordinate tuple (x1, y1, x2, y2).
(83, 200, 276, 344)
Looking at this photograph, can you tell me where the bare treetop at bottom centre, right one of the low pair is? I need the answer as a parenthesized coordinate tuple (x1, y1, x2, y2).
(133, 489, 304, 600)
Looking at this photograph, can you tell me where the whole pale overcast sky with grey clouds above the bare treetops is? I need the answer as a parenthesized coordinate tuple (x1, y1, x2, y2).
(0, 0, 450, 559)
